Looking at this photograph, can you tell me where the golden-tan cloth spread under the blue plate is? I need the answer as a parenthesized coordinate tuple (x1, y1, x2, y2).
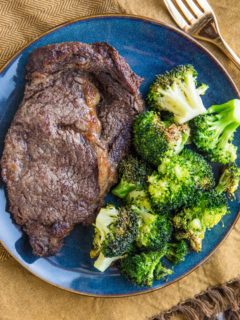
(0, 0, 240, 320)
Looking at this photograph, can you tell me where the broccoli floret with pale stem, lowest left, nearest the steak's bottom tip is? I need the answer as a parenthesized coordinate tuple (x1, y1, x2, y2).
(90, 205, 138, 271)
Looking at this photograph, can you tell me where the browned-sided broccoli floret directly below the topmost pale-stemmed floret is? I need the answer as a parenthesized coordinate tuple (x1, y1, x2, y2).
(133, 111, 190, 166)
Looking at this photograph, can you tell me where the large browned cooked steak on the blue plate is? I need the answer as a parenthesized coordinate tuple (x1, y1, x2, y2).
(1, 42, 143, 256)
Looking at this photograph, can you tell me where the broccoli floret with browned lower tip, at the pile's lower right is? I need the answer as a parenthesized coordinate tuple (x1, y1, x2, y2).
(173, 190, 228, 252)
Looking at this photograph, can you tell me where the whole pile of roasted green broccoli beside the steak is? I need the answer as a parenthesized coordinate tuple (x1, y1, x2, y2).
(90, 65, 240, 286)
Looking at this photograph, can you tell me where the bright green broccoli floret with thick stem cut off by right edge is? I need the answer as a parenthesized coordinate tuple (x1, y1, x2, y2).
(191, 99, 240, 164)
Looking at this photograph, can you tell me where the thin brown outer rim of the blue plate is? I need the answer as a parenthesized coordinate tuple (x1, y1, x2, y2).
(0, 13, 240, 298)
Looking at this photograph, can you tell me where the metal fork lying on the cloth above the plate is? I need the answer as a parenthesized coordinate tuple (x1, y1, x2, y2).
(164, 0, 240, 69)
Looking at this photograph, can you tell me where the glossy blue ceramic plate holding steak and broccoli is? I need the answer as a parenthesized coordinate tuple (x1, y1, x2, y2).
(0, 16, 240, 296)
